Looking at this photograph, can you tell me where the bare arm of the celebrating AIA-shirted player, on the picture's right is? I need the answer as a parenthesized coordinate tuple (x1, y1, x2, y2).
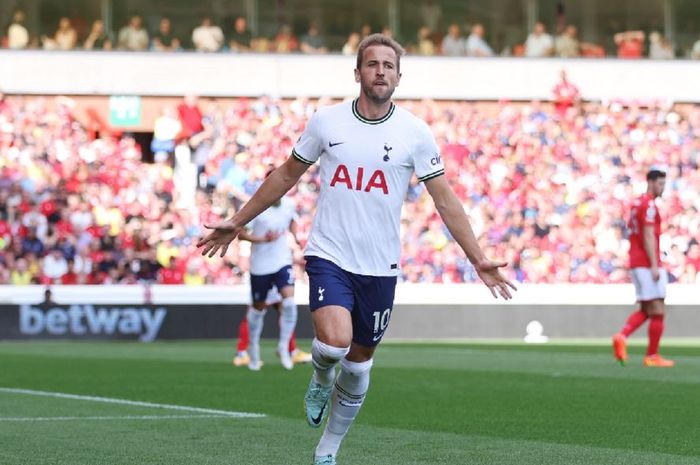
(425, 176, 516, 299)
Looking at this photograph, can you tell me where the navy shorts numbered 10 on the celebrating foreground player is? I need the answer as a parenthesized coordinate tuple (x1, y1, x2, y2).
(305, 256, 396, 347)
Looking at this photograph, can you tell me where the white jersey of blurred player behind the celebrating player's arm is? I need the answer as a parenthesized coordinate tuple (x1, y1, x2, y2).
(248, 197, 296, 275)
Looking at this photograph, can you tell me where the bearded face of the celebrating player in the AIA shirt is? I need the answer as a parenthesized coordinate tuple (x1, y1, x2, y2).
(355, 45, 401, 105)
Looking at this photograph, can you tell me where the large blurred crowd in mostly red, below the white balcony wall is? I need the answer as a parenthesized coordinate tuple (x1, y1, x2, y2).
(0, 95, 700, 285)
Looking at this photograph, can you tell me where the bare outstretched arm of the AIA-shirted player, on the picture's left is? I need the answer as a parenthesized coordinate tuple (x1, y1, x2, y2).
(197, 157, 310, 257)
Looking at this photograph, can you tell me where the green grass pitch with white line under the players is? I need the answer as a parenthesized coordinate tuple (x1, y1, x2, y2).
(0, 341, 700, 465)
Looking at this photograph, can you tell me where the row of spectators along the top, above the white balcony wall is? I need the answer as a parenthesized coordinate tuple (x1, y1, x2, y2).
(5, 7, 700, 59)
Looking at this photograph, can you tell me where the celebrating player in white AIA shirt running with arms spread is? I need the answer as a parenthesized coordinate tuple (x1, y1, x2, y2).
(197, 34, 515, 465)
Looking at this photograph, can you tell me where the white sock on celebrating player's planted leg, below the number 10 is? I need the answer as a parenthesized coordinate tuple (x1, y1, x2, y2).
(316, 359, 372, 457)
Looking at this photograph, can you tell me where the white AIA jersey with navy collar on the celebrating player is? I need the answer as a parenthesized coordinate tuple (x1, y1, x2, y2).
(292, 100, 445, 276)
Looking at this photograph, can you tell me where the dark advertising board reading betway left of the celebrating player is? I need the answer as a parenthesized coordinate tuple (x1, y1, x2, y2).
(0, 304, 311, 342)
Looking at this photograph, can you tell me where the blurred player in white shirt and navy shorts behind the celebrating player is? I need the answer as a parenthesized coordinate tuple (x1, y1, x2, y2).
(238, 192, 297, 371)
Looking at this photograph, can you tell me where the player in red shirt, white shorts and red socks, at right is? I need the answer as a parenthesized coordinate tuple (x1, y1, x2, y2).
(613, 167, 674, 367)
